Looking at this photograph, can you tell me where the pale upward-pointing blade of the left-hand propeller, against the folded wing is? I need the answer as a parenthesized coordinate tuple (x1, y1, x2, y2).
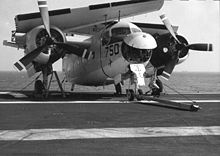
(38, 0, 51, 37)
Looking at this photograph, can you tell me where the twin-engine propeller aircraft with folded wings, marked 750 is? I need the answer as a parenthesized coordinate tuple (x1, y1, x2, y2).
(4, 0, 212, 100)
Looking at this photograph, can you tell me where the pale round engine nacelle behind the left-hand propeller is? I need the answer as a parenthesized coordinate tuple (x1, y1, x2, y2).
(25, 25, 66, 64)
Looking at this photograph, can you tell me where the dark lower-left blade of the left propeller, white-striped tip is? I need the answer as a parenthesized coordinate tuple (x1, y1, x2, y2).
(14, 44, 47, 71)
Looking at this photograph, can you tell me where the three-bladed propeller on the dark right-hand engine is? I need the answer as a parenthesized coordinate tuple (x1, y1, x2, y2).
(160, 14, 213, 80)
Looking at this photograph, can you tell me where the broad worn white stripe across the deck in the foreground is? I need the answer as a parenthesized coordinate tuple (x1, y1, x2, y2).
(0, 126, 220, 141)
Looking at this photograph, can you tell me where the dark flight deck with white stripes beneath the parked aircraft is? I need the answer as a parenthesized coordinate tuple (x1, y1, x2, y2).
(0, 92, 220, 155)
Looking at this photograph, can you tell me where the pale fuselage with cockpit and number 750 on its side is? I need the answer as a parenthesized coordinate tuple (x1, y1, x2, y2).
(63, 22, 156, 86)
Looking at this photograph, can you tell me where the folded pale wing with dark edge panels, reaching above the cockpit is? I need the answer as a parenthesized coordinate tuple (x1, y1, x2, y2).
(15, 0, 164, 33)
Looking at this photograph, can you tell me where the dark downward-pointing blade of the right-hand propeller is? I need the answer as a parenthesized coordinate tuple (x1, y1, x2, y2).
(161, 59, 177, 80)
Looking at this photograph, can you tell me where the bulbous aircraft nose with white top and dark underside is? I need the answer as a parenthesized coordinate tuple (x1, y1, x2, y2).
(122, 32, 157, 63)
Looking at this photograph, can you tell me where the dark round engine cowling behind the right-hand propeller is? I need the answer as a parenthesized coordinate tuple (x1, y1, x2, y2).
(150, 34, 189, 72)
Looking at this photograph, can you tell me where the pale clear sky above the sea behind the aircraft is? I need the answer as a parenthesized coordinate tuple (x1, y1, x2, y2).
(0, 0, 220, 72)
